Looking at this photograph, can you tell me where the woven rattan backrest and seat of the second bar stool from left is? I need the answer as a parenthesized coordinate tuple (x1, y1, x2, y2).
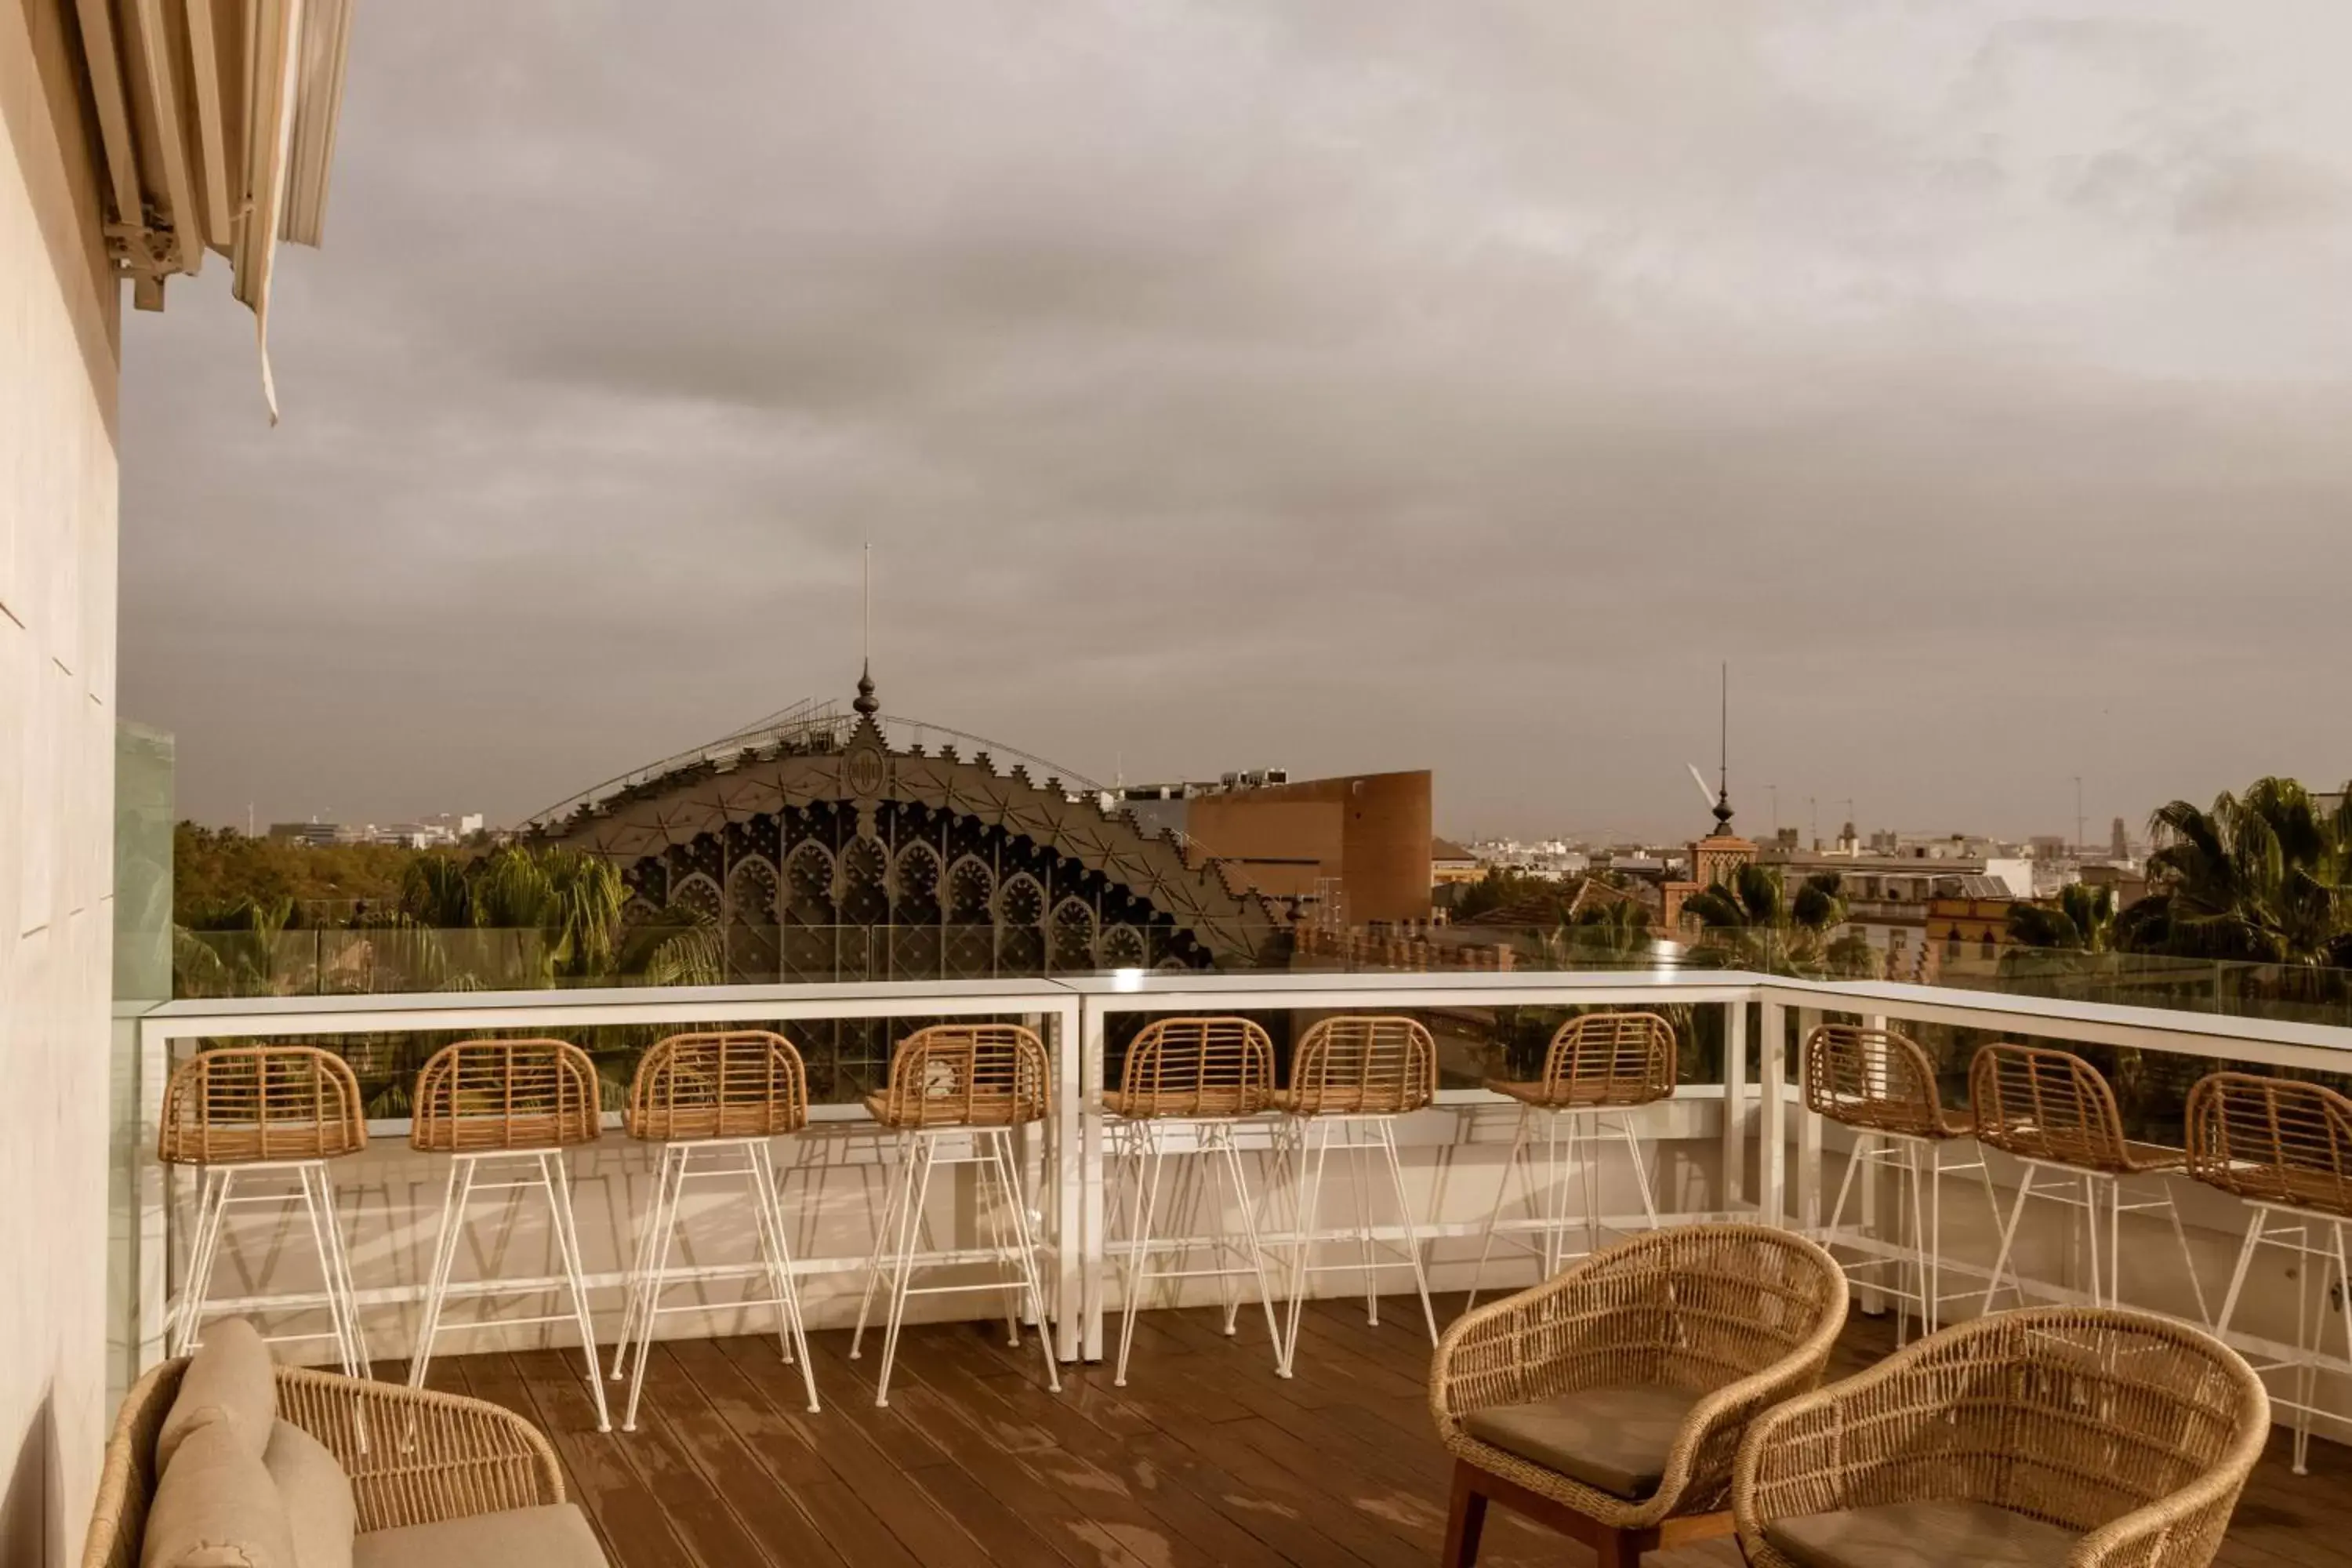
(409, 1039, 602, 1154)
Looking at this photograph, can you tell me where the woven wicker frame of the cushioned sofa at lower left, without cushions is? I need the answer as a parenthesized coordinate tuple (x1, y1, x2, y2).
(82, 1356, 564, 1568)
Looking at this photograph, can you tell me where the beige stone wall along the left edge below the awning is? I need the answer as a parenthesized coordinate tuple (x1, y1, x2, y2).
(0, 0, 120, 1563)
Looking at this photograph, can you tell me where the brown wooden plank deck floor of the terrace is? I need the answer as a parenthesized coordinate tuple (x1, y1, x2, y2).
(433, 1300, 2352, 1568)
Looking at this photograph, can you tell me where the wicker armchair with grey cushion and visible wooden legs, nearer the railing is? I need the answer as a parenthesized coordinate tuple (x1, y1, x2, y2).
(1430, 1225, 1846, 1568)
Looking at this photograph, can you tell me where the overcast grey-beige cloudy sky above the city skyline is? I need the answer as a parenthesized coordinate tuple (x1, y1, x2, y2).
(122, 0, 2352, 837)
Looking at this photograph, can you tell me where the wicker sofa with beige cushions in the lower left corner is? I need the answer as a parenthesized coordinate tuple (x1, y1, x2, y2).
(82, 1319, 607, 1568)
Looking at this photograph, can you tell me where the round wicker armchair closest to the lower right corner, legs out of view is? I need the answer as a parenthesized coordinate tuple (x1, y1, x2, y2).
(1731, 1307, 2270, 1568)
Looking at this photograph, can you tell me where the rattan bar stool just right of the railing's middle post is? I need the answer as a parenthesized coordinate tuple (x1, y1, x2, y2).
(1103, 1018, 1291, 1387)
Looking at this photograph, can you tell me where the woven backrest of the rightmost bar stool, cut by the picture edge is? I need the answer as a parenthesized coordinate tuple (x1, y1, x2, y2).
(2187, 1072, 2352, 1218)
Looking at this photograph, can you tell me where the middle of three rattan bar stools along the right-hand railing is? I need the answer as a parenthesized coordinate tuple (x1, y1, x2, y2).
(1969, 1041, 2211, 1323)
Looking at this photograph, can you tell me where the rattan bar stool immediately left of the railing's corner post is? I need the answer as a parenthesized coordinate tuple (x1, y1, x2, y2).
(1463, 1013, 1675, 1312)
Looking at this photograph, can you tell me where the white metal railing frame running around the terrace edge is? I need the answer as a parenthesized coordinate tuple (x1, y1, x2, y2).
(136, 971, 2352, 1410)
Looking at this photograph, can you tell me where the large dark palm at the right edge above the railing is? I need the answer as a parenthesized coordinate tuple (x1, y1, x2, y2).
(2119, 779, 2352, 968)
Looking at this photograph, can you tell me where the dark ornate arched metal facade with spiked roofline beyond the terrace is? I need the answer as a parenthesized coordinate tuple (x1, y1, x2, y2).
(539, 701, 1289, 1076)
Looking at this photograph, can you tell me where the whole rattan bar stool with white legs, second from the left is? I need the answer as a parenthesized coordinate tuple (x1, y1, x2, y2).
(409, 1039, 612, 1432)
